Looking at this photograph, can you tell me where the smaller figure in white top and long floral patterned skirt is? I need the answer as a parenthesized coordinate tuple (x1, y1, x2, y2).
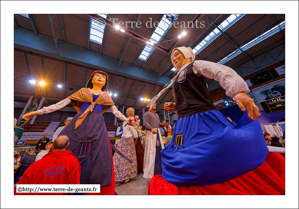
(113, 107, 138, 183)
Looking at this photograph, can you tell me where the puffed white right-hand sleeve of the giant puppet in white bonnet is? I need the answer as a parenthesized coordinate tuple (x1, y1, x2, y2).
(193, 60, 250, 97)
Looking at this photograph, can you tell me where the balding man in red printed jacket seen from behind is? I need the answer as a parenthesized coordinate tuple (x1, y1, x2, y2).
(15, 135, 81, 195)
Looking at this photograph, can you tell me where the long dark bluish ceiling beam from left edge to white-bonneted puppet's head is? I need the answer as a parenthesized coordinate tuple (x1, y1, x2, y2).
(14, 27, 170, 86)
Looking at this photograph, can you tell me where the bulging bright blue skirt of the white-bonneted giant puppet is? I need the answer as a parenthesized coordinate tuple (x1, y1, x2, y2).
(161, 110, 268, 186)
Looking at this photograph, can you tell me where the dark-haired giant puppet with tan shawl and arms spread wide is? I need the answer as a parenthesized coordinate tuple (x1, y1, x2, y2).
(23, 70, 127, 195)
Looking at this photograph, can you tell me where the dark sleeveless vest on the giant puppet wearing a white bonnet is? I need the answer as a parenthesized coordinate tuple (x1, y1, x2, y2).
(172, 63, 216, 119)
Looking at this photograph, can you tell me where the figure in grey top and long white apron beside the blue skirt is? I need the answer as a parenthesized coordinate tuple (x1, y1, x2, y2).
(143, 103, 164, 178)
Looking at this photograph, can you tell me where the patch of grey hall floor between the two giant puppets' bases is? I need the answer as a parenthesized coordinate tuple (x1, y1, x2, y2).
(115, 172, 151, 195)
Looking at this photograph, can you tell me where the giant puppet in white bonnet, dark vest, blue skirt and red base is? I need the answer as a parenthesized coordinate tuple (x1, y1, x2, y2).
(149, 47, 285, 195)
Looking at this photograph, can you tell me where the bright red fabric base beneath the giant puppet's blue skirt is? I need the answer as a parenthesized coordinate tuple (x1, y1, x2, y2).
(148, 152, 285, 195)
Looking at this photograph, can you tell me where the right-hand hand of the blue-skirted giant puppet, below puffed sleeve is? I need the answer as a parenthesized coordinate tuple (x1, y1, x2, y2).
(233, 93, 260, 120)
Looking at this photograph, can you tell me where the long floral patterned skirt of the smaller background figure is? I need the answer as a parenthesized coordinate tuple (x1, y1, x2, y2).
(113, 138, 137, 182)
